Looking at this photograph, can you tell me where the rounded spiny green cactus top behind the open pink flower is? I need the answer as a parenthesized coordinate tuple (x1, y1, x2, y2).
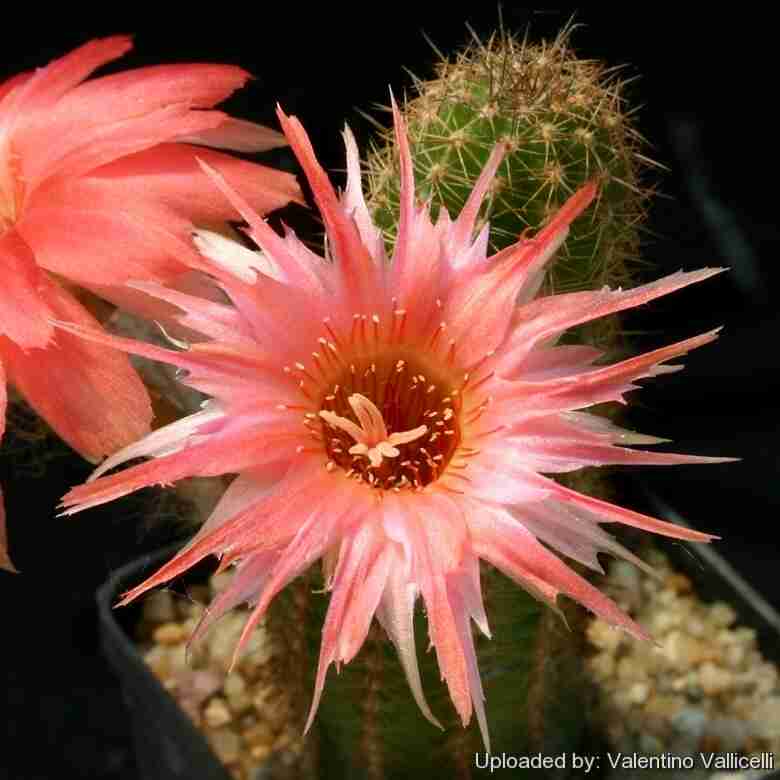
(367, 27, 656, 344)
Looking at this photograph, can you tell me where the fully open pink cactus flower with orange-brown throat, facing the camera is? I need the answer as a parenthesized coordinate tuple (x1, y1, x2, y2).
(63, 100, 732, 746)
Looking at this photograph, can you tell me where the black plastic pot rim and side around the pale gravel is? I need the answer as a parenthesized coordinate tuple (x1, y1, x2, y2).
(97, 494, 780, 780)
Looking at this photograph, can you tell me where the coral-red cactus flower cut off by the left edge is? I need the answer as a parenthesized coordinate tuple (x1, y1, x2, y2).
(0, 36, 300, 566)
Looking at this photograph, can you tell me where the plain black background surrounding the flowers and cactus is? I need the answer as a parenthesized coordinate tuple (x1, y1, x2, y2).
(0, 7, 780, 780)
